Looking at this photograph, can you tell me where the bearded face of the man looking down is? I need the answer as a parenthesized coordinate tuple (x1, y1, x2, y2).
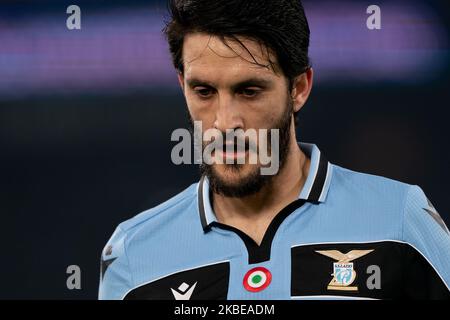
(179, 33, 293, 197)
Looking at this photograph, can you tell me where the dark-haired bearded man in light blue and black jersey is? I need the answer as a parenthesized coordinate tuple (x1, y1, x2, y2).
(99, 0, 450, 300)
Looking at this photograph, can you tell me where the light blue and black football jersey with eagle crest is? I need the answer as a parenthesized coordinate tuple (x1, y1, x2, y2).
(99, 143, 450, 300)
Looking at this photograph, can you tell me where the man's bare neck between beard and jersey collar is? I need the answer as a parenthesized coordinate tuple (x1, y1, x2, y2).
(212, 140, 311, 244)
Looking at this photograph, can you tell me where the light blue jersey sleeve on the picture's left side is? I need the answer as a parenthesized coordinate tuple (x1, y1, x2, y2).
(98, 227, 132, 300)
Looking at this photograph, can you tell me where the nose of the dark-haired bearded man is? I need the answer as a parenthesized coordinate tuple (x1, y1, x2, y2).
(214, 94, 244, 133)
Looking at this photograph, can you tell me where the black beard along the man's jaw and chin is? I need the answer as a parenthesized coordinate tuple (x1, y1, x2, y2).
(200, 100, 294, 198)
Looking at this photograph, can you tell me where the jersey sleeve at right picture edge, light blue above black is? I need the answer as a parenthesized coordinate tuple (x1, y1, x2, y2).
(403, 186, 450, 299)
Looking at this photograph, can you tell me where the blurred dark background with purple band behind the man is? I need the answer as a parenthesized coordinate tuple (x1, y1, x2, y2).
(0, 0, 450, 299)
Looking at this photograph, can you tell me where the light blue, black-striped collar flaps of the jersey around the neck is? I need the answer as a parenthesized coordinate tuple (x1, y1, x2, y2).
(197, 142, 332, 231)
